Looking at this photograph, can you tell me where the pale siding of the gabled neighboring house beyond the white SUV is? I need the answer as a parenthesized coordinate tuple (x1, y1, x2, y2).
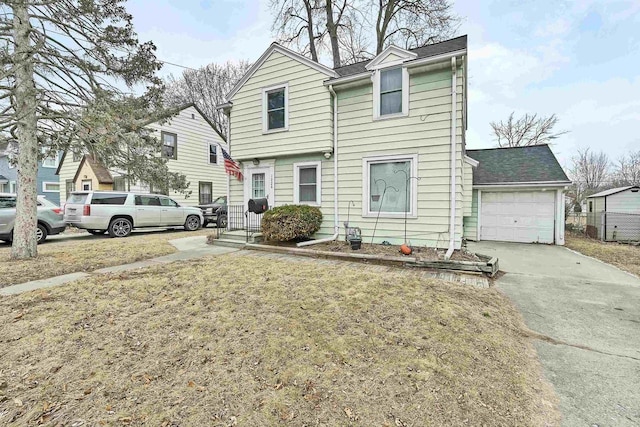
(148, 107, 227, 206)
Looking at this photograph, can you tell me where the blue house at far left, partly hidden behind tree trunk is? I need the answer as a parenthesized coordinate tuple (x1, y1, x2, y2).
(0, 142, 62, 205)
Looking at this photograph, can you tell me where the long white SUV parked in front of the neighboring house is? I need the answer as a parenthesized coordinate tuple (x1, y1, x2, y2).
(64, 191, 203, 237)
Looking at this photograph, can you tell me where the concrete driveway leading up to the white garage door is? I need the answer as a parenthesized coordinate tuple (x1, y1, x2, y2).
(469, 242, 640, 426)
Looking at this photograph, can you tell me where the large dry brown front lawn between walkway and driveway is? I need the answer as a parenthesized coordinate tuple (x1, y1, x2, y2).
(0, 254, 558, 426)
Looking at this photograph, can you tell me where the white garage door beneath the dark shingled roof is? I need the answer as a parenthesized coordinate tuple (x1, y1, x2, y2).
(480, 191, 556, 243)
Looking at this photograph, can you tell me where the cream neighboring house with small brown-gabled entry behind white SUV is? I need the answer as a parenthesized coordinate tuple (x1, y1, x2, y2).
(57, 104, 227, 205)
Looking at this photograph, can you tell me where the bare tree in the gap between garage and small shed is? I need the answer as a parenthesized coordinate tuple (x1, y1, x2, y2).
(569, 148, 611, 211)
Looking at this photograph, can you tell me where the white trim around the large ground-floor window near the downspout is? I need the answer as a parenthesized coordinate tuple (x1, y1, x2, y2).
(362, 154, 418, 218)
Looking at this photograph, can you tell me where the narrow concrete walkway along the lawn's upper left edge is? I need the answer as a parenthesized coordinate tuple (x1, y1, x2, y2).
(0, 236, 237, 296)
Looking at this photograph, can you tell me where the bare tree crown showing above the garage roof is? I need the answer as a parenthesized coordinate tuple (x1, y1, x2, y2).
(491, 113, 567, 147)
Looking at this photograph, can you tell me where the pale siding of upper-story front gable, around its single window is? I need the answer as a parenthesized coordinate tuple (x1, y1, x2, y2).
(231, 52, 333, 160)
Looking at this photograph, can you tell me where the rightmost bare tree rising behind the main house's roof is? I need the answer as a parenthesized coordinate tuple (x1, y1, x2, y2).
(376, 0, 460, 53)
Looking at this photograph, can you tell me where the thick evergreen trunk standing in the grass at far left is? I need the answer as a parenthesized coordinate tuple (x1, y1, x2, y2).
(11, 1, 38, 259)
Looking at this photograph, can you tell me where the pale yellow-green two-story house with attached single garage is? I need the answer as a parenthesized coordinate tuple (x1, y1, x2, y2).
(219, 36, 568, 250)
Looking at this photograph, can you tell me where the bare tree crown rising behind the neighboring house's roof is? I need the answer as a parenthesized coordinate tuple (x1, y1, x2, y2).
(164, 61, 251, 136)
